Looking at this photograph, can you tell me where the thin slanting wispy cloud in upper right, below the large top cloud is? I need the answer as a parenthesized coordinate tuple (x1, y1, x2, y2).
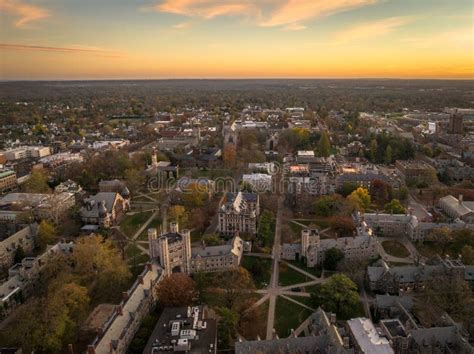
(336, 17, 413, 43)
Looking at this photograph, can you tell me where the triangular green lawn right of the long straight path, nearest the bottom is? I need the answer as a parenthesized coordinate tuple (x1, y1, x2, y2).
(275, 297, 312, 338)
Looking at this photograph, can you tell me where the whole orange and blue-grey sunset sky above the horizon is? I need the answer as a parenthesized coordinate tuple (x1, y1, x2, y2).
(0, 0, 474, 80)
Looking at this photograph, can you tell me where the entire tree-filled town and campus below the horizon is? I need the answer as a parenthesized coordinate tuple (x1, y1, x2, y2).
(0, 80, 474, 354)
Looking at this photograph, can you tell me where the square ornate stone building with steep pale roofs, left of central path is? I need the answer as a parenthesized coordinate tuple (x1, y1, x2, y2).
(217, 192, 260, 235)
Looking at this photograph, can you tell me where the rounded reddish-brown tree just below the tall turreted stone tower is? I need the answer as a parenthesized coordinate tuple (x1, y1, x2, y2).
(156, 273, 197, 307)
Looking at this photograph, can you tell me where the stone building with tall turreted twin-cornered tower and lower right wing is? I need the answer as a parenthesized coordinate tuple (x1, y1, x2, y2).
(148, 223, 244, 275)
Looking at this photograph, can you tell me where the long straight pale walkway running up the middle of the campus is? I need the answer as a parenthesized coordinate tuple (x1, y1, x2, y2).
(266, 196, 283, 340)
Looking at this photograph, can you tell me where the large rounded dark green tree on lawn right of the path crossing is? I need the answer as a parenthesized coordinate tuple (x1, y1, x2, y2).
(311, 274, 359, 319)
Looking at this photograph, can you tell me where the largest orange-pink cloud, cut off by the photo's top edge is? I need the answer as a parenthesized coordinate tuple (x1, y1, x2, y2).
(153, 0, 380, 30)
